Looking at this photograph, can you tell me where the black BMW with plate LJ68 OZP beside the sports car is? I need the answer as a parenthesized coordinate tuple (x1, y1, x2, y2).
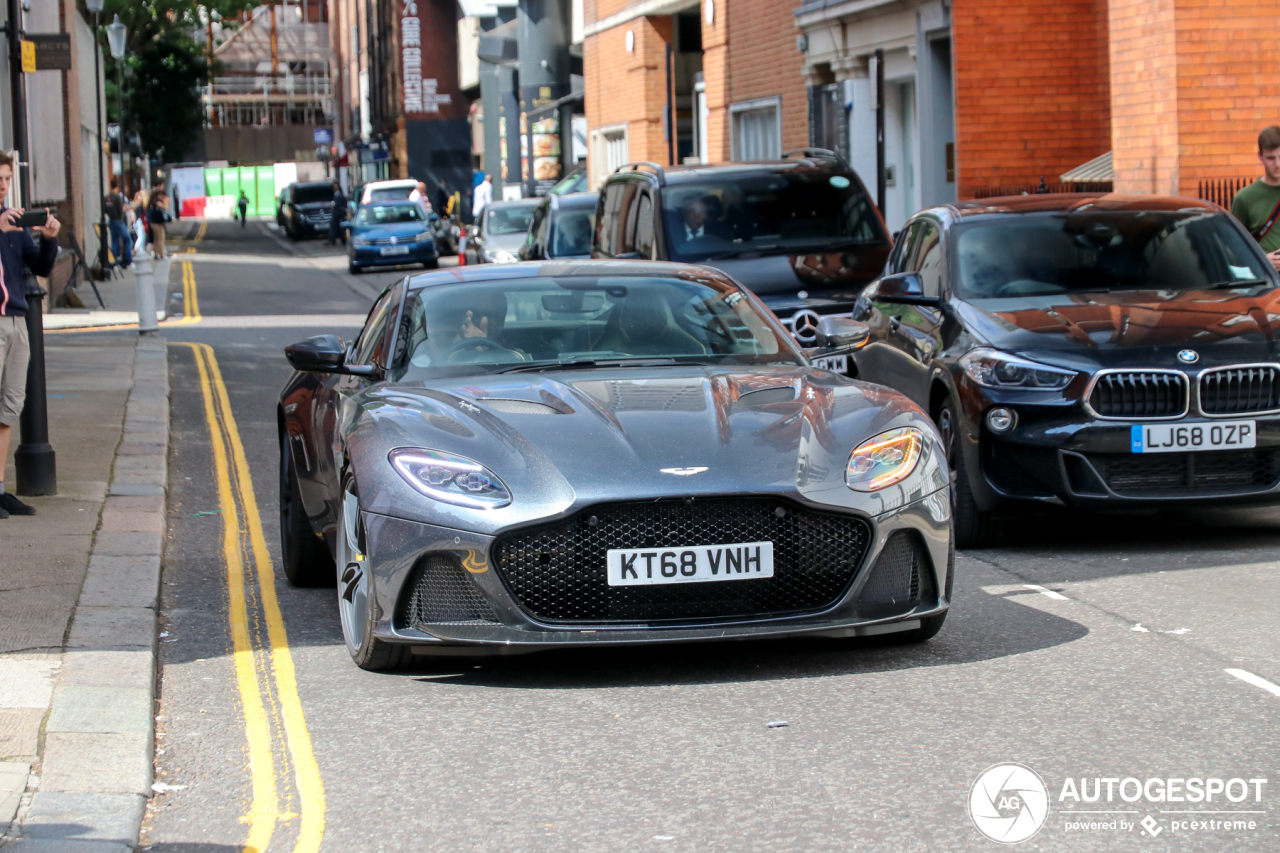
(854, 195, 1280, 547)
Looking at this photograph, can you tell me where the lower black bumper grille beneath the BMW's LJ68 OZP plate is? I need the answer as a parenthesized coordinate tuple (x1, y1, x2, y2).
(1089, 448, 1280, 496)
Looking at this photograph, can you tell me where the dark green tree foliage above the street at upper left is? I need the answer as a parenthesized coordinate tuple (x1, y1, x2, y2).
(81, 0, 257, 161)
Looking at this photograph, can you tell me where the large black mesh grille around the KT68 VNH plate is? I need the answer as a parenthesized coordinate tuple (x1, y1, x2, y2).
(493, 497, 870, 622)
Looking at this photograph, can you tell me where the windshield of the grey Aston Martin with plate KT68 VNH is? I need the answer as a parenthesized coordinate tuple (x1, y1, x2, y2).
(390, 275, 803, 380)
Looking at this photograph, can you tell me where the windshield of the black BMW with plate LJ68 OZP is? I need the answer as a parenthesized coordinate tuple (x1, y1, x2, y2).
(955, 210, 1272, 300)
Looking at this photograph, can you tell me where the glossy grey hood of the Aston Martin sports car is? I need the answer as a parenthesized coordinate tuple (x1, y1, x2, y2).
(343, 368, 948, 532)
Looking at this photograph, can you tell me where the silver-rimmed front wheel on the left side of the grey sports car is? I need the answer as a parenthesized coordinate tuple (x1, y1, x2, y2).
(335, 470, 413, 671)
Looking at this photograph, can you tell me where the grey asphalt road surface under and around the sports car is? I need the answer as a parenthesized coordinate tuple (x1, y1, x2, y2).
(143, 223, 1280, 853)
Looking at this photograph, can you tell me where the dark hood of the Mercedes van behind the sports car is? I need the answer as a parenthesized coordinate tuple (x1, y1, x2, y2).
(701, 245, 890, 303)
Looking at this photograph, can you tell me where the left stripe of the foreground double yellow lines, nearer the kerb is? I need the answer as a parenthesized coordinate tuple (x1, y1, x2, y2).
(175, 343, 276, 853)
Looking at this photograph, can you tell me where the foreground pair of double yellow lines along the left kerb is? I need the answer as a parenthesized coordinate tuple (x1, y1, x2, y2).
(181, 343, 325, 853)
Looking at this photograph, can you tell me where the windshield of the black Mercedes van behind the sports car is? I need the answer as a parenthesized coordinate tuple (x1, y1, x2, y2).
(663, 169, 888, 263)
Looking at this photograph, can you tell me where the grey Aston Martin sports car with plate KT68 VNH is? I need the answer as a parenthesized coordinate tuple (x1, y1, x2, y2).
(279, 261, 954, 670)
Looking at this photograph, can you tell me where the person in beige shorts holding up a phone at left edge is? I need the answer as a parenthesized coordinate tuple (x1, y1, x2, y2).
(0, 151, 61, 519)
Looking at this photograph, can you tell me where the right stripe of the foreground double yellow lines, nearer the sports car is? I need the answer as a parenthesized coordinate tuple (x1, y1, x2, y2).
(195, 343, 325, 853)
